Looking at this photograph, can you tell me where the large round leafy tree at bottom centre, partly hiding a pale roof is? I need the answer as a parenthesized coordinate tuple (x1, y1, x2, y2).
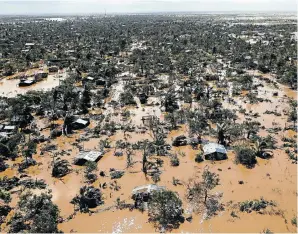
(148, 190, 183, 228)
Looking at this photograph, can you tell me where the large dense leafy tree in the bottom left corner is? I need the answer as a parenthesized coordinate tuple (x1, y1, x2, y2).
(9, 192, 59, 233)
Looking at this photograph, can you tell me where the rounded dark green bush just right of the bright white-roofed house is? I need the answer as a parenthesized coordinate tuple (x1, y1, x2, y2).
(235, 146, 257, 168)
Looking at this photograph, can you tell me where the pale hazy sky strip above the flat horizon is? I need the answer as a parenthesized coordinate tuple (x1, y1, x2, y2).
(0, 0, 297, 15)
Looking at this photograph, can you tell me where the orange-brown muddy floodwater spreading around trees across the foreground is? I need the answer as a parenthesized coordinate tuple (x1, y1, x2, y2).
(0, 70, 297, 233)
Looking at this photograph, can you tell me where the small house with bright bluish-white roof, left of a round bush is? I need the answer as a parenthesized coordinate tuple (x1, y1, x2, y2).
(203, 143, 228, 160)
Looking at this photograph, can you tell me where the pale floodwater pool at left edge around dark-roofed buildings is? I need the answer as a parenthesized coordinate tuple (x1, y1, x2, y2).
(0, 72, 67, 97)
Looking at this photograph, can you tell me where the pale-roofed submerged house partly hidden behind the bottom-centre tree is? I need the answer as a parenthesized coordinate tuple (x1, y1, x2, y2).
(132, 184, 166, 202)
